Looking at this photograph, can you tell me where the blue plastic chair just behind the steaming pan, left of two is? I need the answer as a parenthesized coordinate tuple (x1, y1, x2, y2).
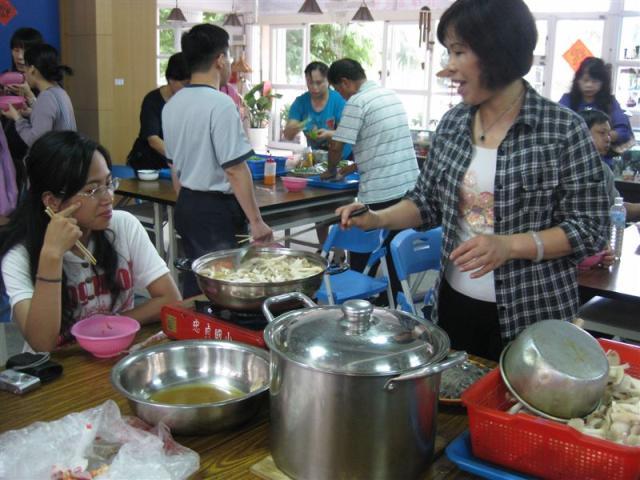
(316, 225, 394, 308)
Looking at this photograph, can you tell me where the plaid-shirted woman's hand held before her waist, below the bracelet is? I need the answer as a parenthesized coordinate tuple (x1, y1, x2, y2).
(449, 235, 511, 278)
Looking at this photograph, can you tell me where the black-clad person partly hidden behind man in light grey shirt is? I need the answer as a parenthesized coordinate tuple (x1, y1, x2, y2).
(127, 52, 191, 170)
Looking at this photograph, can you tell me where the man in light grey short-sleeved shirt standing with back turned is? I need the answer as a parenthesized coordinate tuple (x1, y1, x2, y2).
(162, 24, 272, 297)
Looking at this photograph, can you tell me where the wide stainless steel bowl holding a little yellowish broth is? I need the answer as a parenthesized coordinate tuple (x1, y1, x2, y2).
(111, 340, 269, 435)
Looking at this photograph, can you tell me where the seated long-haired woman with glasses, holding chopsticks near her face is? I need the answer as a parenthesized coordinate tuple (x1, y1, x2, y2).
(0, 131, 180, 351)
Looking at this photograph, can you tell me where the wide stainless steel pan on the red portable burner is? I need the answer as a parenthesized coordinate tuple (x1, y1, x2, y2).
(186, 247, 327, 311)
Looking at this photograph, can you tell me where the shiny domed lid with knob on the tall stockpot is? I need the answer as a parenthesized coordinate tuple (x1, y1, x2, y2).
(263, 294, 449, 375)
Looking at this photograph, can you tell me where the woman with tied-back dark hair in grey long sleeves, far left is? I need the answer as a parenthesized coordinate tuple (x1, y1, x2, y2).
(2, 44, 76, 146)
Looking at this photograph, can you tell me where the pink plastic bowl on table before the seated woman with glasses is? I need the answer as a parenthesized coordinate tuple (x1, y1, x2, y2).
(71, 314, 140, 358)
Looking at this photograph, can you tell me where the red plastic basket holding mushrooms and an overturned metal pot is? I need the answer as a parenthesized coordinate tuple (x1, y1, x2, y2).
(462, 339, 640, 480)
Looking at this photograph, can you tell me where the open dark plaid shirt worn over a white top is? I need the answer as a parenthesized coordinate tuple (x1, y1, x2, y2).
(407, 82, 609, 341)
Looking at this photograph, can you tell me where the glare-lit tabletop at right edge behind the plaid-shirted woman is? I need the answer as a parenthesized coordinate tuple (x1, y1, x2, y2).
(578, 225, 640, 302)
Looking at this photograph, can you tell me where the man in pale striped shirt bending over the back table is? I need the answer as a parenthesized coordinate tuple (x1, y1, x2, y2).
(323, 58, 419, 295)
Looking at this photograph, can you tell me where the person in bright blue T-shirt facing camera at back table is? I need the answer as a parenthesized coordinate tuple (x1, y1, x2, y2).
(284, 62, 351, 158)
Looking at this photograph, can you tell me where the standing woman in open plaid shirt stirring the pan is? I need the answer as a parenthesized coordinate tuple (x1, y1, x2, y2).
(338, 0, 608, 360)
